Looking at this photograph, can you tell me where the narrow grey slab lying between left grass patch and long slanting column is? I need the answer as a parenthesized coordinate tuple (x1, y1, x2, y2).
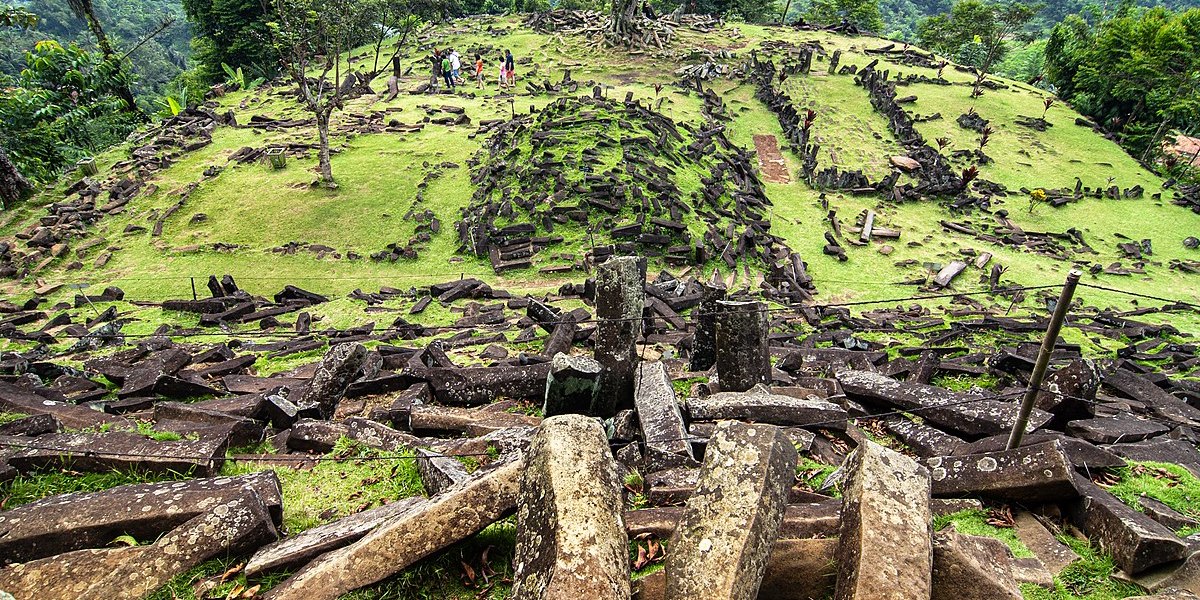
(246, 497, 428, 577)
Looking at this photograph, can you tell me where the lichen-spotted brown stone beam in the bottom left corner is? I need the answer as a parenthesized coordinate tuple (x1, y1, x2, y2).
(0, 487, 278, 600)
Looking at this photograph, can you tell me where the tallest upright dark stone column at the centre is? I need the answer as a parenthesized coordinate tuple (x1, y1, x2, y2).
(592, 257, 646, 416)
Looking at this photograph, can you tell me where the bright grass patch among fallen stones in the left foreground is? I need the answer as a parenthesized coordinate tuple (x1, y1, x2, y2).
(221, 438, 422, 534)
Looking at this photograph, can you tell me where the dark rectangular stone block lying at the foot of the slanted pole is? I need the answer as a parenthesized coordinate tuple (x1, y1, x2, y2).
(926, 440, 1075, 503)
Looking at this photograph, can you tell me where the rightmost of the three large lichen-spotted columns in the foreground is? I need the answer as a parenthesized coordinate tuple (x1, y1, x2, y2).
(834, 439, 934, 600)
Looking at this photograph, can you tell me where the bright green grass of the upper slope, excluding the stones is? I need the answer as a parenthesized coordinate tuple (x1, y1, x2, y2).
(5, 19, 1200, 328)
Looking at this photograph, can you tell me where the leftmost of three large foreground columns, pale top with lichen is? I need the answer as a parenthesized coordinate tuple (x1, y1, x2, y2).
(512, 415, 630, 600)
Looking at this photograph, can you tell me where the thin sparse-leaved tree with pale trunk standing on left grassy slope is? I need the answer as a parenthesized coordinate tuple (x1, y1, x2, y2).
(268, 0, 370, 188)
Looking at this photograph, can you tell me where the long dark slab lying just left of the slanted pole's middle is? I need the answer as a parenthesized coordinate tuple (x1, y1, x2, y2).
(838, 371, 1052, 437)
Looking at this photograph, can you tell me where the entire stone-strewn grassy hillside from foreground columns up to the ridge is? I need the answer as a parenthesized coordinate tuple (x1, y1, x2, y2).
(0, 13, 1200, 600)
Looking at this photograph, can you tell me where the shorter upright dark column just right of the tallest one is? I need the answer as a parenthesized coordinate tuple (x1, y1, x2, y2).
(716, 300, 770, 391)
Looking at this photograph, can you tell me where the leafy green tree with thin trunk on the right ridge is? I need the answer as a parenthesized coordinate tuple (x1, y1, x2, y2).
(917, 0, 1045, 95)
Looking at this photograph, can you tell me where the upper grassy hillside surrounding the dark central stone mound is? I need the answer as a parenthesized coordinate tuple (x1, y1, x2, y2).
(5, 12, 1198, 324)
